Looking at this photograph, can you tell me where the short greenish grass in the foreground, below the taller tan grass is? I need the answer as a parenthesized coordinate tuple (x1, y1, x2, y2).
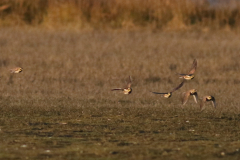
(0, 99, 240, 159)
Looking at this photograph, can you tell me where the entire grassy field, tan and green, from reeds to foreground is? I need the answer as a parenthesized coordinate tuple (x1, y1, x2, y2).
(0, 28, 240, 160)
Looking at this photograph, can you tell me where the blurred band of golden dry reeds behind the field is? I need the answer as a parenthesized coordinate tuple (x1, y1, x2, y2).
(0, 0, 240, 29)
